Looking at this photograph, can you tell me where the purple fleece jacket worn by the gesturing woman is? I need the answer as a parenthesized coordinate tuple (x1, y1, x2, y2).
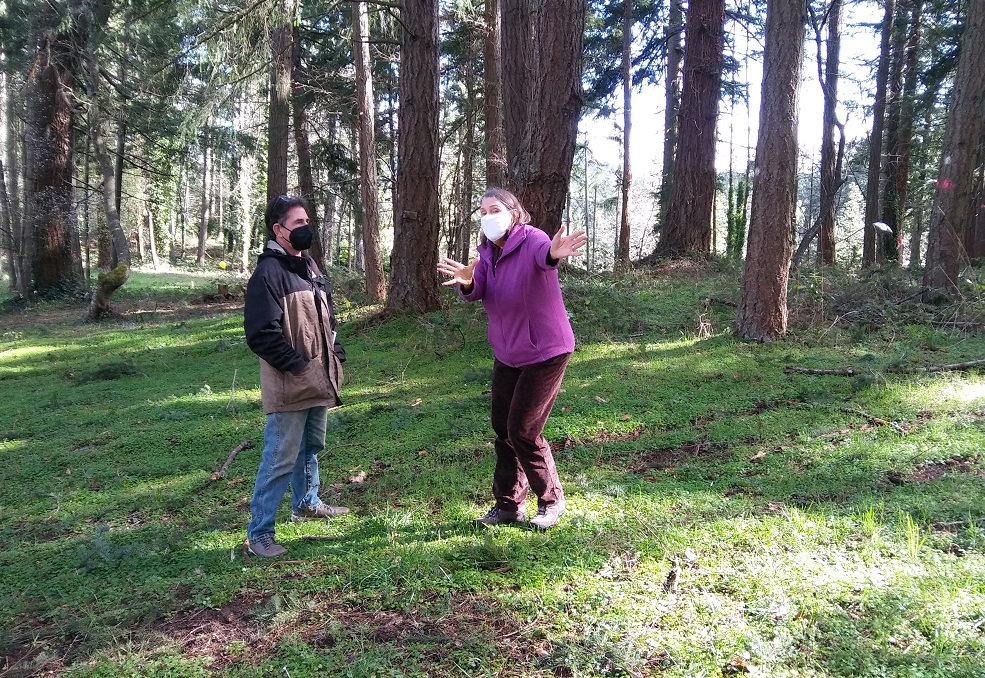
(459, 224, 575, 367)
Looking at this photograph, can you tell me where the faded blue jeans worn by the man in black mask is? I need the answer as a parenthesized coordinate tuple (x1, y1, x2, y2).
(246, 407, 328, 542)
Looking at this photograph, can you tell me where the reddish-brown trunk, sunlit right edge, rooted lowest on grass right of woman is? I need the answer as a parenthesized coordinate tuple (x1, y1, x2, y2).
(735, 0, 807, 341)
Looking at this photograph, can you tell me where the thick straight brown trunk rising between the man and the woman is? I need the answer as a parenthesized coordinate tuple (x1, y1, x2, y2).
(387, 0, 440, 313)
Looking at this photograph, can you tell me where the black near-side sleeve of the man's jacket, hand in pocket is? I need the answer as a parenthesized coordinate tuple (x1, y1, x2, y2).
(243, 268, 308, 374)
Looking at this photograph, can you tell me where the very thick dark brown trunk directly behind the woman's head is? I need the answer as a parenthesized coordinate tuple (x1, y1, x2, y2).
(503, 0, 585, 235)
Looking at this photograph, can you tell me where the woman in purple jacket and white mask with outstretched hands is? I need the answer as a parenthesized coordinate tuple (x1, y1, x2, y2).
(438, 188, 588, 529)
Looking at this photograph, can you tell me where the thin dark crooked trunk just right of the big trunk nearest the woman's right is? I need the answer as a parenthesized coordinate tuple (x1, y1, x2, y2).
(817, 0, 845, 266)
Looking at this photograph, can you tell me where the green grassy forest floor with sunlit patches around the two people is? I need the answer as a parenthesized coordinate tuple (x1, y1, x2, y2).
(0, 263, 985, 678)
